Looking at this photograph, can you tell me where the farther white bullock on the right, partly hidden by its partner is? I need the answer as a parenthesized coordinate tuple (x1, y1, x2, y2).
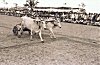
(46, 18, 61, 38)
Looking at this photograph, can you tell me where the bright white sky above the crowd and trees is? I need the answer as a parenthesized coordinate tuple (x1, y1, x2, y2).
(0, 0, 100, 13)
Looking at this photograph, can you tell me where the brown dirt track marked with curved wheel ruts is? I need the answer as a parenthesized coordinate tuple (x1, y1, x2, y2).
(0, 15, 100, 65)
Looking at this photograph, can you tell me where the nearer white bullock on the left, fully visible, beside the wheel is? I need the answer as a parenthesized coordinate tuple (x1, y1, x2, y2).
(18, 16, 46, 42)
